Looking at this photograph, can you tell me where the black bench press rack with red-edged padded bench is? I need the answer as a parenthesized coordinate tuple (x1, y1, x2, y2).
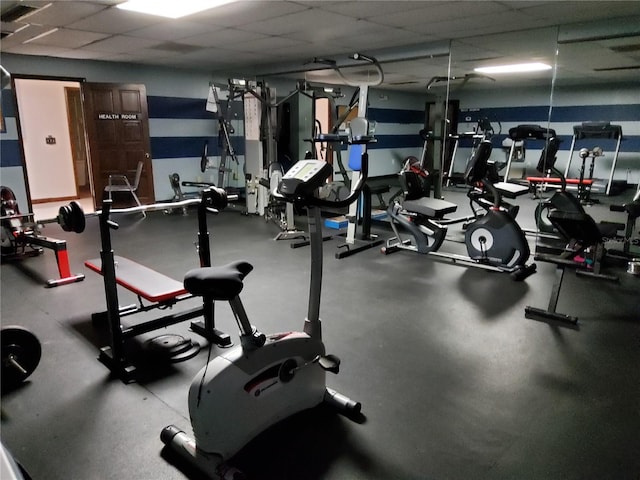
(85, 188, 232, 383)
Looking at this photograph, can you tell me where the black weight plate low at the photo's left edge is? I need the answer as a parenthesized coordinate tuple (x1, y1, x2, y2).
(0, 326, 42, 387)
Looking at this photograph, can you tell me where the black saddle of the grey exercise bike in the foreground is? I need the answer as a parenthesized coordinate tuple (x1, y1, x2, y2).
(184, 260, 253, 300)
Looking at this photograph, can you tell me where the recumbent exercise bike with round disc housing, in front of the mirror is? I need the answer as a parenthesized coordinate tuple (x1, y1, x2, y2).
(382, 140, 536, 281)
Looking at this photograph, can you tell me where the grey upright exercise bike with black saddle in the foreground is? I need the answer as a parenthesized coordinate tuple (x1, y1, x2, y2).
(161, 118, 370, 479)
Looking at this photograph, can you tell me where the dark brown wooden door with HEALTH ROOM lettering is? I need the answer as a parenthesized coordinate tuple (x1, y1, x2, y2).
(82, 82, 155, 207)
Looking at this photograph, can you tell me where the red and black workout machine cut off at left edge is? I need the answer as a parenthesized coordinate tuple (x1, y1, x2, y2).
(0, 187, 84, 287)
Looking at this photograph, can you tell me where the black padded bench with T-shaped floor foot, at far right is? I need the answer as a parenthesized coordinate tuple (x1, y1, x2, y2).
(525, 210, 618, 325)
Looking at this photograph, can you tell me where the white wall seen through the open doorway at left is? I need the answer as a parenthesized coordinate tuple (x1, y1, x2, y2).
(15, 79, 79, 201)
